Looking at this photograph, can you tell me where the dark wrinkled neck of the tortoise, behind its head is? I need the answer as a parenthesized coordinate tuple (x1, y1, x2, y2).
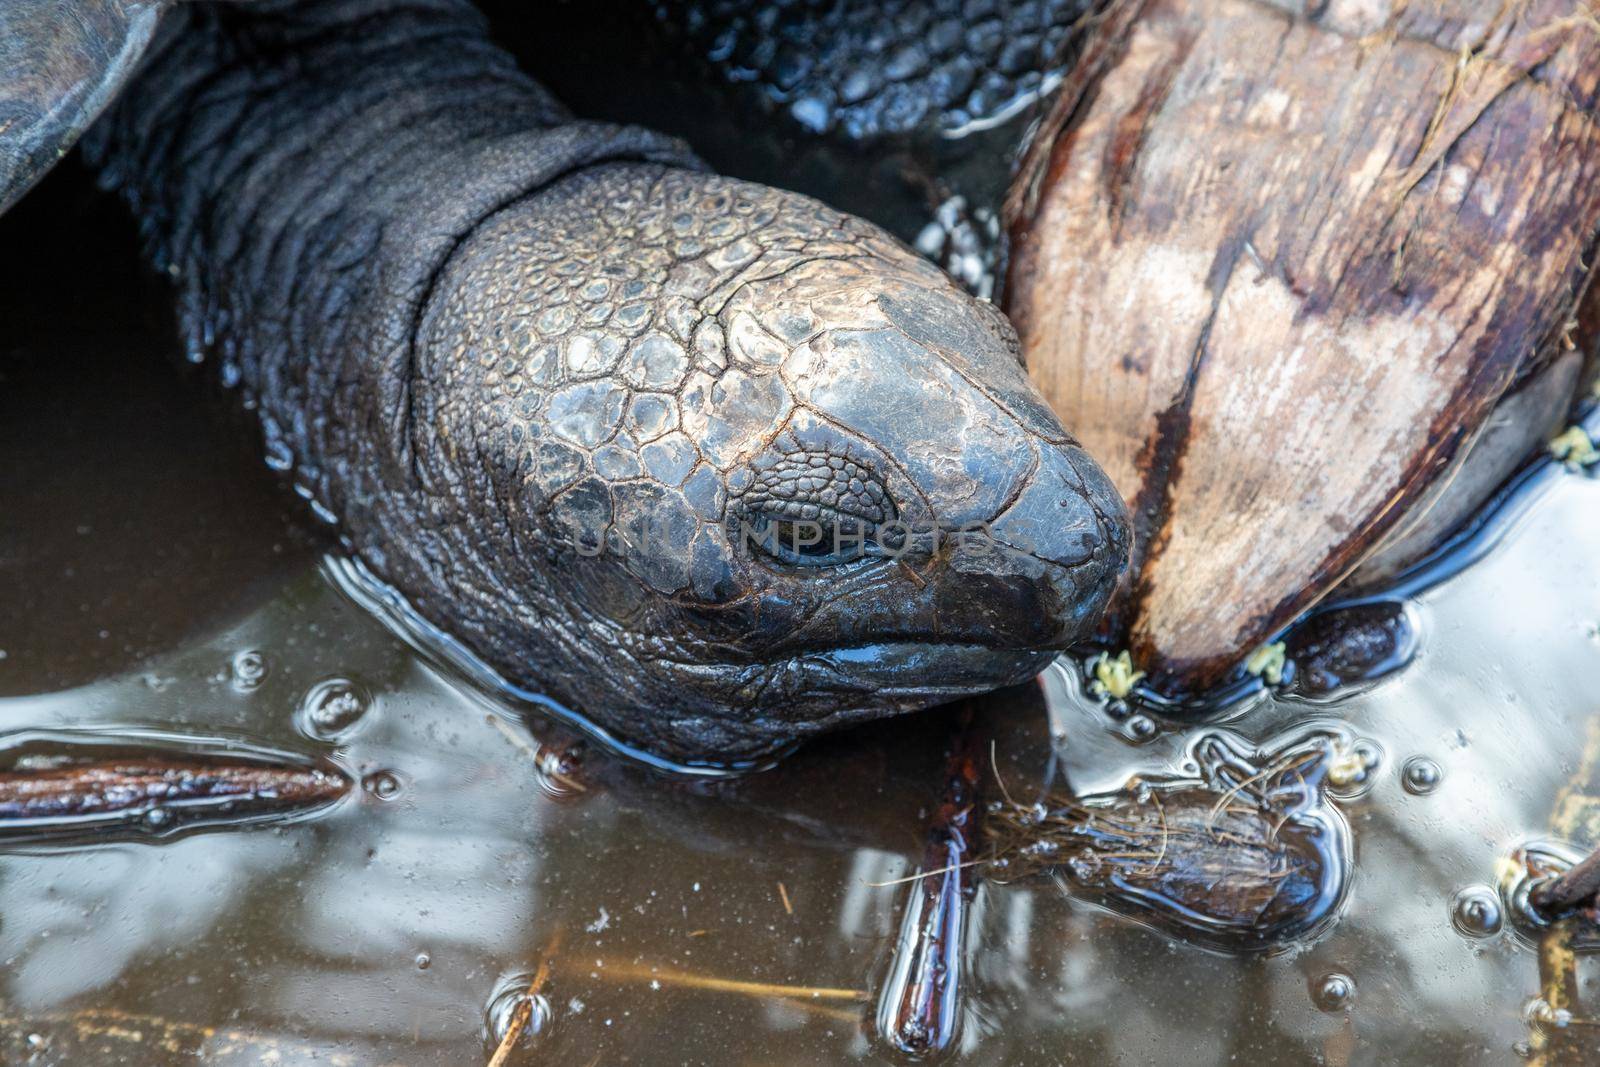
(85, 0, 690, 515)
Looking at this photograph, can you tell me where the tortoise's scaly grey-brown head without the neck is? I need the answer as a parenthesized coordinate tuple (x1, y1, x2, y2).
(418, 165, 1128, 755)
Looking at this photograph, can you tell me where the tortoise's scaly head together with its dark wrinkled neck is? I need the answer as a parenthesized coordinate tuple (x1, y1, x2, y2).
(88, 0, 1126, 758)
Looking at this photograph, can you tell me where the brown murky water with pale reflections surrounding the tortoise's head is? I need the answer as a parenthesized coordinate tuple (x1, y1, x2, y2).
(0, 115, 1600, 1064)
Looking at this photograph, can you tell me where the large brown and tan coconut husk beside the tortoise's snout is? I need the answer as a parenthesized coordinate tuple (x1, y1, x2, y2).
(1006, 0, 1600, 693)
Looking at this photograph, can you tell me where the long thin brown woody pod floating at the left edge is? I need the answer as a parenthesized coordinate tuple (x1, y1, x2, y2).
(0, 757, 350, 841)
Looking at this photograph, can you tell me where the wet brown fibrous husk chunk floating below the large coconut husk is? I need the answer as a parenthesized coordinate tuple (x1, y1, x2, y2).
(986, 731, 1350, 952)
